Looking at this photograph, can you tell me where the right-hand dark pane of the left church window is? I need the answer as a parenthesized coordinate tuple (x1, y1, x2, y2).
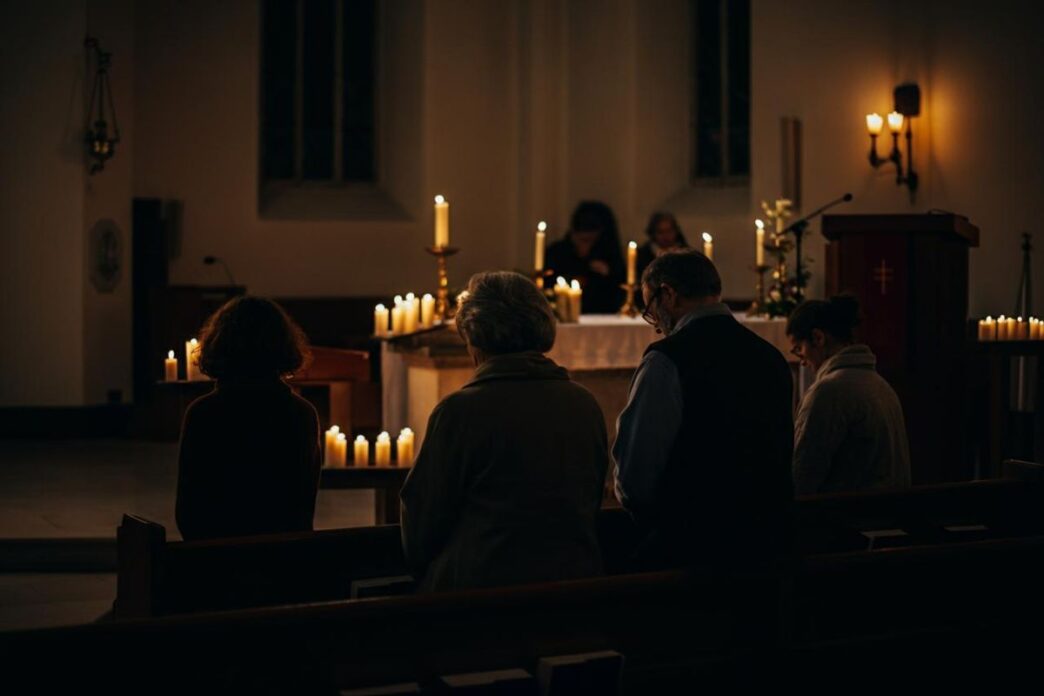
(341, 0, 377, 182)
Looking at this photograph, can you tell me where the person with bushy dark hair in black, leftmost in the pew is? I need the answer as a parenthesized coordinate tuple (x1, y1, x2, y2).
(175, 297, 322, 539)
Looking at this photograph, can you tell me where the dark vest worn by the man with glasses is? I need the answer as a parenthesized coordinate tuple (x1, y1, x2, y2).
(646, 315, 793, 566)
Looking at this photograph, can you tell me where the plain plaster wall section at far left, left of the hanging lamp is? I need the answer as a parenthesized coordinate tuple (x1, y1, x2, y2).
(0, 1, 86, 406)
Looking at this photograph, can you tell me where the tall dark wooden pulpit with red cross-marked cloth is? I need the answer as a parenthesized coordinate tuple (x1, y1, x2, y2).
(823, 213, 978, 484)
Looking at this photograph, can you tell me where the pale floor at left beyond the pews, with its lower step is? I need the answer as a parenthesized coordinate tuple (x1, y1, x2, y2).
(0, 440, 374, 630)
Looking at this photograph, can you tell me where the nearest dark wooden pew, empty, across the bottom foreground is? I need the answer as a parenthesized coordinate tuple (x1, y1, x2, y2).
(6, 536, 1044, 693)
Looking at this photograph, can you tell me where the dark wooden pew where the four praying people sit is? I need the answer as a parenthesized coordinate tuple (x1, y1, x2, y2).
(114, 470, 1044, 619)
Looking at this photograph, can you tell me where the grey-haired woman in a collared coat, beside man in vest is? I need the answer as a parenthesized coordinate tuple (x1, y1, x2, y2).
(400, 272, 609, 591)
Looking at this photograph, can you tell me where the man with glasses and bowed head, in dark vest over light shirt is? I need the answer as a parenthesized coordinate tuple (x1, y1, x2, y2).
(613, 250, 793, 569)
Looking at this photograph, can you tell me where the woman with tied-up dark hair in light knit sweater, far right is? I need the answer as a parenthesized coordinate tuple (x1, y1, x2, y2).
(786, 295, 910, 496)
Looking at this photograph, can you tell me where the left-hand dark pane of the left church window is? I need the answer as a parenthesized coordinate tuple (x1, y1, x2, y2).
(261, 0, 298, 178)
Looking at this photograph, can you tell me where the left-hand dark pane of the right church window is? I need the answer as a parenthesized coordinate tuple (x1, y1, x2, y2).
(693, 0, 722, 178)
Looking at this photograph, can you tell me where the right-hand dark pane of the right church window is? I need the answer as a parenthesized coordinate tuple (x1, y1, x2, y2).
(727, 0, 751, 175)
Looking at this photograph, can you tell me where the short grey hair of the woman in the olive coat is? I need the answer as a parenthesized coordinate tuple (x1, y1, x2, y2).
(456, 271, 554, 355)
